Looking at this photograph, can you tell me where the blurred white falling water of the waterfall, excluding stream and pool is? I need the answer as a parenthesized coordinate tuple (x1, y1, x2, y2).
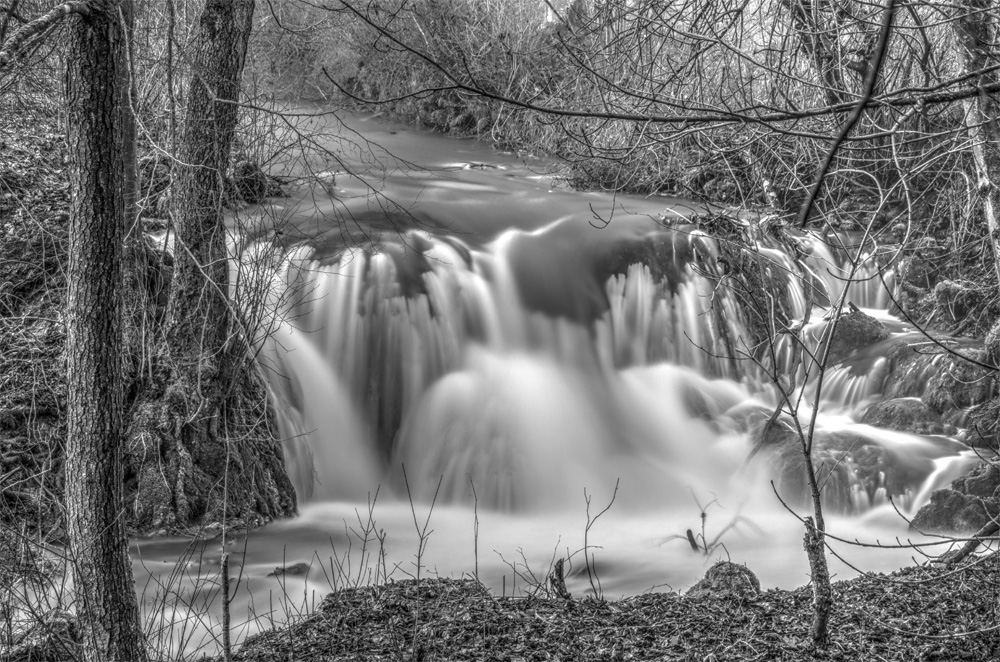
(260, 215, 961, 512)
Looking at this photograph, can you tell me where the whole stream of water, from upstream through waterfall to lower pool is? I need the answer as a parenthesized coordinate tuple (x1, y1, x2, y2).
(129, 110, 973, 660)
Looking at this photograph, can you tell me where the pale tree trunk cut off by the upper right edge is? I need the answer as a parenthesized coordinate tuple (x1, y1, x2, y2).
(954, 0, 1000, 282)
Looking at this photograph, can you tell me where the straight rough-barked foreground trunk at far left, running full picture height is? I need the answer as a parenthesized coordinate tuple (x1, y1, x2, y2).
(66, 2, 146, 660)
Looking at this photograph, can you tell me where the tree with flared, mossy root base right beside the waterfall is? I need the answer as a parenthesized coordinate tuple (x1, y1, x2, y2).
(132, 0, 295, 530)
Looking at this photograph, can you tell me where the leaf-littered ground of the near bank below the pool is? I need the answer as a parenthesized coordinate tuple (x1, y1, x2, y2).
(229, 555, 1000, 662)
